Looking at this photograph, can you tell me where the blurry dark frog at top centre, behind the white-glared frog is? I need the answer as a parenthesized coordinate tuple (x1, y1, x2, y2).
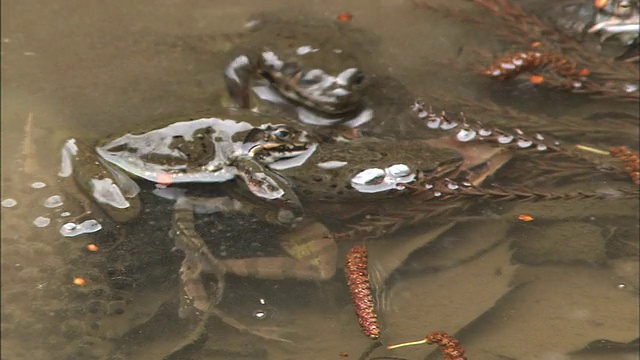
(223, 14, 412, 136)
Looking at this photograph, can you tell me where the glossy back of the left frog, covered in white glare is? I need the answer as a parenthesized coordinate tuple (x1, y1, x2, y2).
(96, 118, 253, 183)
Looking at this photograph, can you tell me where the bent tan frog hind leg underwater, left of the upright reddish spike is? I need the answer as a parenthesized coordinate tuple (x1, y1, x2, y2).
(221, 222, 338, 280)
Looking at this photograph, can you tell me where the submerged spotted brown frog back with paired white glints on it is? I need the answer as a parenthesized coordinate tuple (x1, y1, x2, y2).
(272, 139, 460, 202)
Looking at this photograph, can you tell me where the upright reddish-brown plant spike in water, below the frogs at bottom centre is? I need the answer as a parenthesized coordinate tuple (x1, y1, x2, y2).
(345, 246, 380, 339)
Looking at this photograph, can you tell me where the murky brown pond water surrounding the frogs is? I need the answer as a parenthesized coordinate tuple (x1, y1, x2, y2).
(1, 0, 639, 360)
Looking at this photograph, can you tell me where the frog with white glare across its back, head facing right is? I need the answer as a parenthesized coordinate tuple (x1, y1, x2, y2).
(58, 111, 317, 328)
